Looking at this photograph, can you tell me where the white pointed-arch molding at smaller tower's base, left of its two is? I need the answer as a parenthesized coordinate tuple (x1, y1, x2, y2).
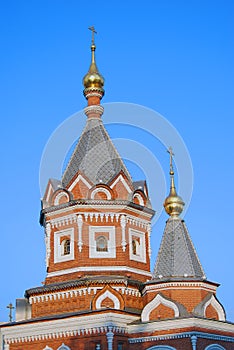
(141, 294, 180, 322)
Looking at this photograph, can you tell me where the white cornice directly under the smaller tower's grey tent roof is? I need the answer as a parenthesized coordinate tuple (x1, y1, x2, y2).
(142, 282, 217, 295)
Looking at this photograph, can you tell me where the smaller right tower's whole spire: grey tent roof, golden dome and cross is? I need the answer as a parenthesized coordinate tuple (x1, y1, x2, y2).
(153, 147, 206, 280)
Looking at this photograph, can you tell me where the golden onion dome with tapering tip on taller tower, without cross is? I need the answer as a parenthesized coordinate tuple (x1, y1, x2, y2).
(83, 44, 104, 89)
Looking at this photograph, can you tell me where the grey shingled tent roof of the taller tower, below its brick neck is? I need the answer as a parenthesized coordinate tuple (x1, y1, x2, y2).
(62, 119, 132, 187)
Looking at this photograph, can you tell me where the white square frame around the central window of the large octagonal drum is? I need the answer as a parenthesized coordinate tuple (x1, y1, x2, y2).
(89, 226, 116, 258)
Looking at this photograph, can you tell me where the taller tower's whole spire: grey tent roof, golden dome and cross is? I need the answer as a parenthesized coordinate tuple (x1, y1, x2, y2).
(62, 27, 132, 187)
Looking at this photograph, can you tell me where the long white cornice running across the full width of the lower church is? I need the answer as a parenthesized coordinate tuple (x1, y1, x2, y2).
(0, 309, 234, 344)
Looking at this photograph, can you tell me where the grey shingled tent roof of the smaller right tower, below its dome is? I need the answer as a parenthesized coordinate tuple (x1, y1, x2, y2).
(153, 217, 205, 280)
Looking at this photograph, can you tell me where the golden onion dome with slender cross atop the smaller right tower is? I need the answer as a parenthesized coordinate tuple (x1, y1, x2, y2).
(164, 147, 184, 217)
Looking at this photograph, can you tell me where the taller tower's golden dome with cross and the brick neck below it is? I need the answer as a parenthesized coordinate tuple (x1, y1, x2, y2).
(83, 26, 104, 118)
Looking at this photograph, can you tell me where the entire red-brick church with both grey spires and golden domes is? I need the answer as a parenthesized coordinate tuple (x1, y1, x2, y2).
(0, 29, 234, 350)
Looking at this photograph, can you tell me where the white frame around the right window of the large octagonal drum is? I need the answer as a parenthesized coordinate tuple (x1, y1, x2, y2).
(129, 228, 146, 263)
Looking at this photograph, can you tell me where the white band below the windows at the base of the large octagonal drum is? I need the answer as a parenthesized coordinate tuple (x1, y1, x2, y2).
(47, 265, 152, 278)
